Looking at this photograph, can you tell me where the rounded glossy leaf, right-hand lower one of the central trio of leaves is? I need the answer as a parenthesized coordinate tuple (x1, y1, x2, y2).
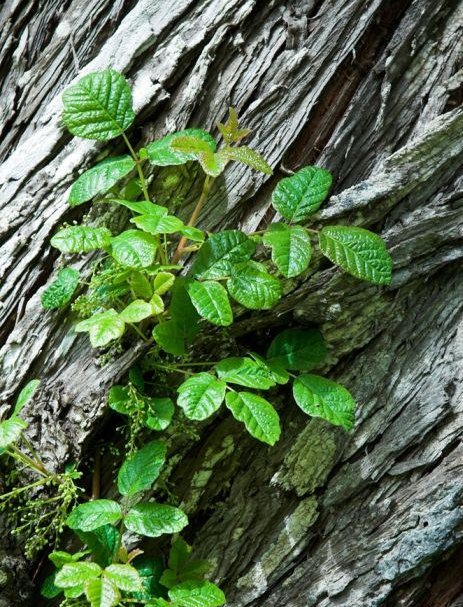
(227, 261, 282, 310)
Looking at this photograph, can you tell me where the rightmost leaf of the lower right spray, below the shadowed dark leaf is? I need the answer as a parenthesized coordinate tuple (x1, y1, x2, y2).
(293, 375, 355, 430)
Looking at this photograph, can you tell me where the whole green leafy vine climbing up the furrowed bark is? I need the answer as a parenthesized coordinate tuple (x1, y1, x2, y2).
(0, 69, 392, 607)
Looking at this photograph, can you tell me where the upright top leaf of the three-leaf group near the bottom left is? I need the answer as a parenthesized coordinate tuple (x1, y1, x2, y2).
(117, 441, 167, 496)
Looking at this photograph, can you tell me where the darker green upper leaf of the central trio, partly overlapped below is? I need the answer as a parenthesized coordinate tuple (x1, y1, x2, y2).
(191, 230, 256, 280)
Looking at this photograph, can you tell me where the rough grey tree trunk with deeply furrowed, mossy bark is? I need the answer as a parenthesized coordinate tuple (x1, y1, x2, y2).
(0, 0, 463, 607)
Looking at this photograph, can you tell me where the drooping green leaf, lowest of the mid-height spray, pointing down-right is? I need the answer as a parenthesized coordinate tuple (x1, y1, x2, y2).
(225, 392, 280, 445)
